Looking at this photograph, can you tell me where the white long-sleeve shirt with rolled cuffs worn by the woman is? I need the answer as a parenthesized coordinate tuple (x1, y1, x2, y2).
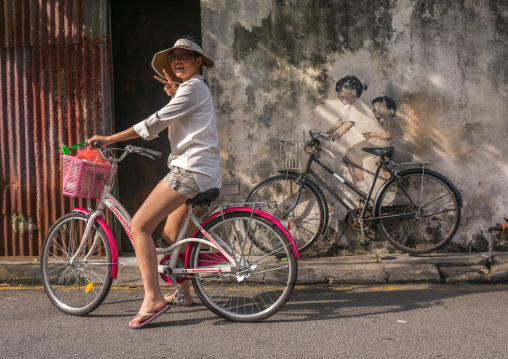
(134, 75, 222, 192)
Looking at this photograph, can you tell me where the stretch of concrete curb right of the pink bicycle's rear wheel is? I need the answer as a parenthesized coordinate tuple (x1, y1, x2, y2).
(298, 253, 508, 284)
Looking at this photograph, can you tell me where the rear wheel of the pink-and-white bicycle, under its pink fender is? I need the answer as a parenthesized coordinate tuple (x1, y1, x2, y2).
(190, 212, 297, 322)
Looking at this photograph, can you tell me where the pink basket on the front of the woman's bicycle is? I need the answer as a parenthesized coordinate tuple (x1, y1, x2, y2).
(62, 155, 112, 199)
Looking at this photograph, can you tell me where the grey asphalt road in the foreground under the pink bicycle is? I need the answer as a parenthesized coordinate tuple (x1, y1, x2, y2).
(0, 284, 508, 359)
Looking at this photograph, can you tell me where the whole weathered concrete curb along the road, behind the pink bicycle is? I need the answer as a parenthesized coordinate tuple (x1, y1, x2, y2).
(0, 252, 508, 286)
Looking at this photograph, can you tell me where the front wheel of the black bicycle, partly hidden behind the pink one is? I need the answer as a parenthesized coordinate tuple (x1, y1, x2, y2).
(247, 174, 328, 254)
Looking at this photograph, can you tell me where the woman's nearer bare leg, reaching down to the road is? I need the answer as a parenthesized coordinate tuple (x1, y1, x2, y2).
(130, 180, 188, 325)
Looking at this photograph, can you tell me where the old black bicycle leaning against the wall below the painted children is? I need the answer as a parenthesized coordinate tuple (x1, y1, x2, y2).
(247, 130, 462, 254)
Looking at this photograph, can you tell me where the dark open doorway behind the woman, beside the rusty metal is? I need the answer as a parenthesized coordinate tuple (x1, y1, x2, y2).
(111, 0, 201, 252)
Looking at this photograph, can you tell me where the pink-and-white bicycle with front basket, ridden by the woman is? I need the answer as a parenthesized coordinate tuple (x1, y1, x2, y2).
(41, 145, 299, 322)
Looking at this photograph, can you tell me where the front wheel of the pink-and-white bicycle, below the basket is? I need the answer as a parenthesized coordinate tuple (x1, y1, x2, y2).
(41, 212, 113, 315)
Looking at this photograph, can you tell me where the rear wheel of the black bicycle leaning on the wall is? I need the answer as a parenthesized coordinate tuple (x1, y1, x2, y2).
(375, 168, 461, 254)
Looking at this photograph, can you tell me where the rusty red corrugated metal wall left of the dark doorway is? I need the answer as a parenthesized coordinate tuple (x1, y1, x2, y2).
(0, 0, 112, 256)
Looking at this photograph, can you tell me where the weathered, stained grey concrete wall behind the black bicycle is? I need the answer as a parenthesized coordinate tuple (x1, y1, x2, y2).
(201, 0, 508, 254)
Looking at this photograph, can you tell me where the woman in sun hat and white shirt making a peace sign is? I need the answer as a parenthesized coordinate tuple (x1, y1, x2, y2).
(88, 37, 222, 329)
